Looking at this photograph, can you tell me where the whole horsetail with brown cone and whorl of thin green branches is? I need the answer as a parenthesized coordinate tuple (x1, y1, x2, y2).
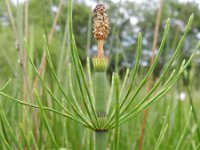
(0, 0, 200, 150)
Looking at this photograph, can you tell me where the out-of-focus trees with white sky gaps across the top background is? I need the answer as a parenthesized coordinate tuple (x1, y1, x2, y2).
(0, 0, 200, 82)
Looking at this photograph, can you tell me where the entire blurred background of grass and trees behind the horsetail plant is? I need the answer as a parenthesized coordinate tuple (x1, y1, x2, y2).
(0, 0, 200, 150)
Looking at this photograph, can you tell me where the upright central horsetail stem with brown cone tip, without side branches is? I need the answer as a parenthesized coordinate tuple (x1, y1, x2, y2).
(93, 4, 109, 150)
